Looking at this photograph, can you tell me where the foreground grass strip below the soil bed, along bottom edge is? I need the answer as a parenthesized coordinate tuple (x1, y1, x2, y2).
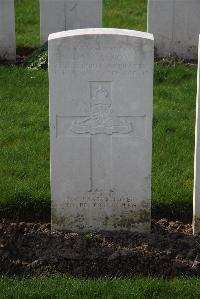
(0, 276, 200, 299)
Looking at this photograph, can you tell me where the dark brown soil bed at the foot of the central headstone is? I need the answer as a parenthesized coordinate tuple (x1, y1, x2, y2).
(0, 219, 200, 278)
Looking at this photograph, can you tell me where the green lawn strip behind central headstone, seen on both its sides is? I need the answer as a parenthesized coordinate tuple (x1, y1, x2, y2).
(0, 64, 196, 218)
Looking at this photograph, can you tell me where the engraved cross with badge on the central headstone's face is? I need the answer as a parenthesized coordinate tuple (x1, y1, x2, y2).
(57, 82, 138, 191)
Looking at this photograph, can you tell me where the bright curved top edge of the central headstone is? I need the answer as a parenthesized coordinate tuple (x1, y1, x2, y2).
(48, 28, 154, 41)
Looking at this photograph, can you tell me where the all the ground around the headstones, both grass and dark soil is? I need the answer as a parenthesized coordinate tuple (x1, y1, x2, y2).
(0, 0, 200, 298)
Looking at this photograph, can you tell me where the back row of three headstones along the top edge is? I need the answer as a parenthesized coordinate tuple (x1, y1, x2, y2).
(0, 0, 200, 60)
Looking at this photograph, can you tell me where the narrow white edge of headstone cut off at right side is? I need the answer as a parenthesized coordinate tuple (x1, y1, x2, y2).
(193, 36, 200, 234)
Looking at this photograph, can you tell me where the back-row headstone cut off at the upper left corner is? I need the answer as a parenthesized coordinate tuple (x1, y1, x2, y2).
(0, 0, 16, 61)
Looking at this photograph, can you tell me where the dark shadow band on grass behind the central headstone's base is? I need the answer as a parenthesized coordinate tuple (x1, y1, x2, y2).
(0, 200, 192, 223)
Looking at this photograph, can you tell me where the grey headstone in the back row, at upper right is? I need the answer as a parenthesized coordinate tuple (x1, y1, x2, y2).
(148, 0, 200, 59)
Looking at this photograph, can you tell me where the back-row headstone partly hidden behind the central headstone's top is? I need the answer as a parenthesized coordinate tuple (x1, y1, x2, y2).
(40, 0, 102, 44)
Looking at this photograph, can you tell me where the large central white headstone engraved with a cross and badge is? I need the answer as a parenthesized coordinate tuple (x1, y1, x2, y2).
(49, 29, 154, 231)
